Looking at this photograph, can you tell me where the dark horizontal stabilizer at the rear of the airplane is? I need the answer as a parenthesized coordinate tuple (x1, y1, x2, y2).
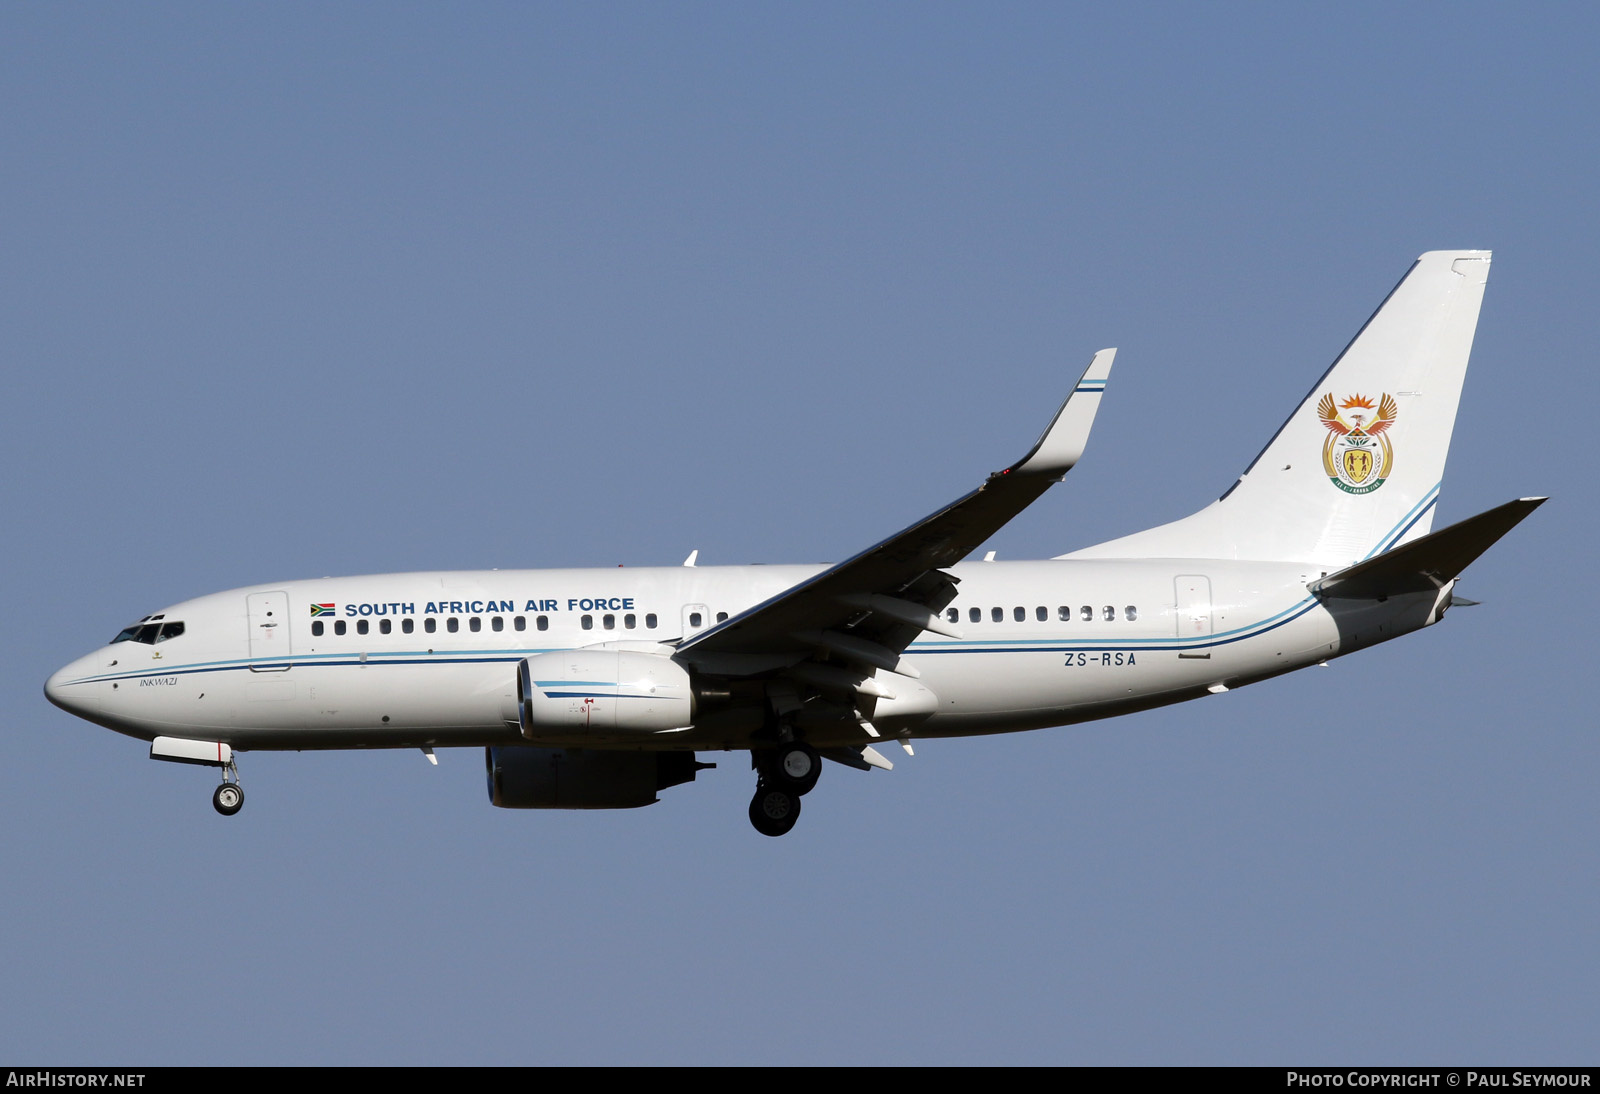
(1310, 497, 1546, 600)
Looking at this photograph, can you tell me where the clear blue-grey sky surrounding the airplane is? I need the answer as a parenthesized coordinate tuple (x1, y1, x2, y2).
(0, 3, 1600, 1064)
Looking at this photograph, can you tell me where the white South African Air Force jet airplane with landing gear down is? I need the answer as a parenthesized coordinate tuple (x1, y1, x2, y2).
(45, 251, 1546, 836)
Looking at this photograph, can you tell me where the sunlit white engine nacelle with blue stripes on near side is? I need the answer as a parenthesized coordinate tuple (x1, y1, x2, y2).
(517, 649, 694, 741)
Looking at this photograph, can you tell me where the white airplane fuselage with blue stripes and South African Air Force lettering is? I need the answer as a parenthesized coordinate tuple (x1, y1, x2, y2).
(46, 560, 1437, 750)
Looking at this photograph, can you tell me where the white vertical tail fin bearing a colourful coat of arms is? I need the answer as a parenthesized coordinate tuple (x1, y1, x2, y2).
(1062, 251, 1490, 566)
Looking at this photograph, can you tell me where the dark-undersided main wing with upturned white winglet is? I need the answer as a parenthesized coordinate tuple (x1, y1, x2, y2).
(675, 349, 1117, 734)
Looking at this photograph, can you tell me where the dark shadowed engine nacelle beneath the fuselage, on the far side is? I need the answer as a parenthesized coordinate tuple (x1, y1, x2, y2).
(483, 745, 712, 809)
